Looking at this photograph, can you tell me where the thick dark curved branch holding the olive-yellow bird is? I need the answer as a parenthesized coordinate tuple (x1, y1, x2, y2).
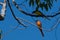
(12, 0, 60, 17)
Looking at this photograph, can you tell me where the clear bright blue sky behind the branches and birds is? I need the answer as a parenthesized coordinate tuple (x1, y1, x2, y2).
(0, 0, 60, 40)
